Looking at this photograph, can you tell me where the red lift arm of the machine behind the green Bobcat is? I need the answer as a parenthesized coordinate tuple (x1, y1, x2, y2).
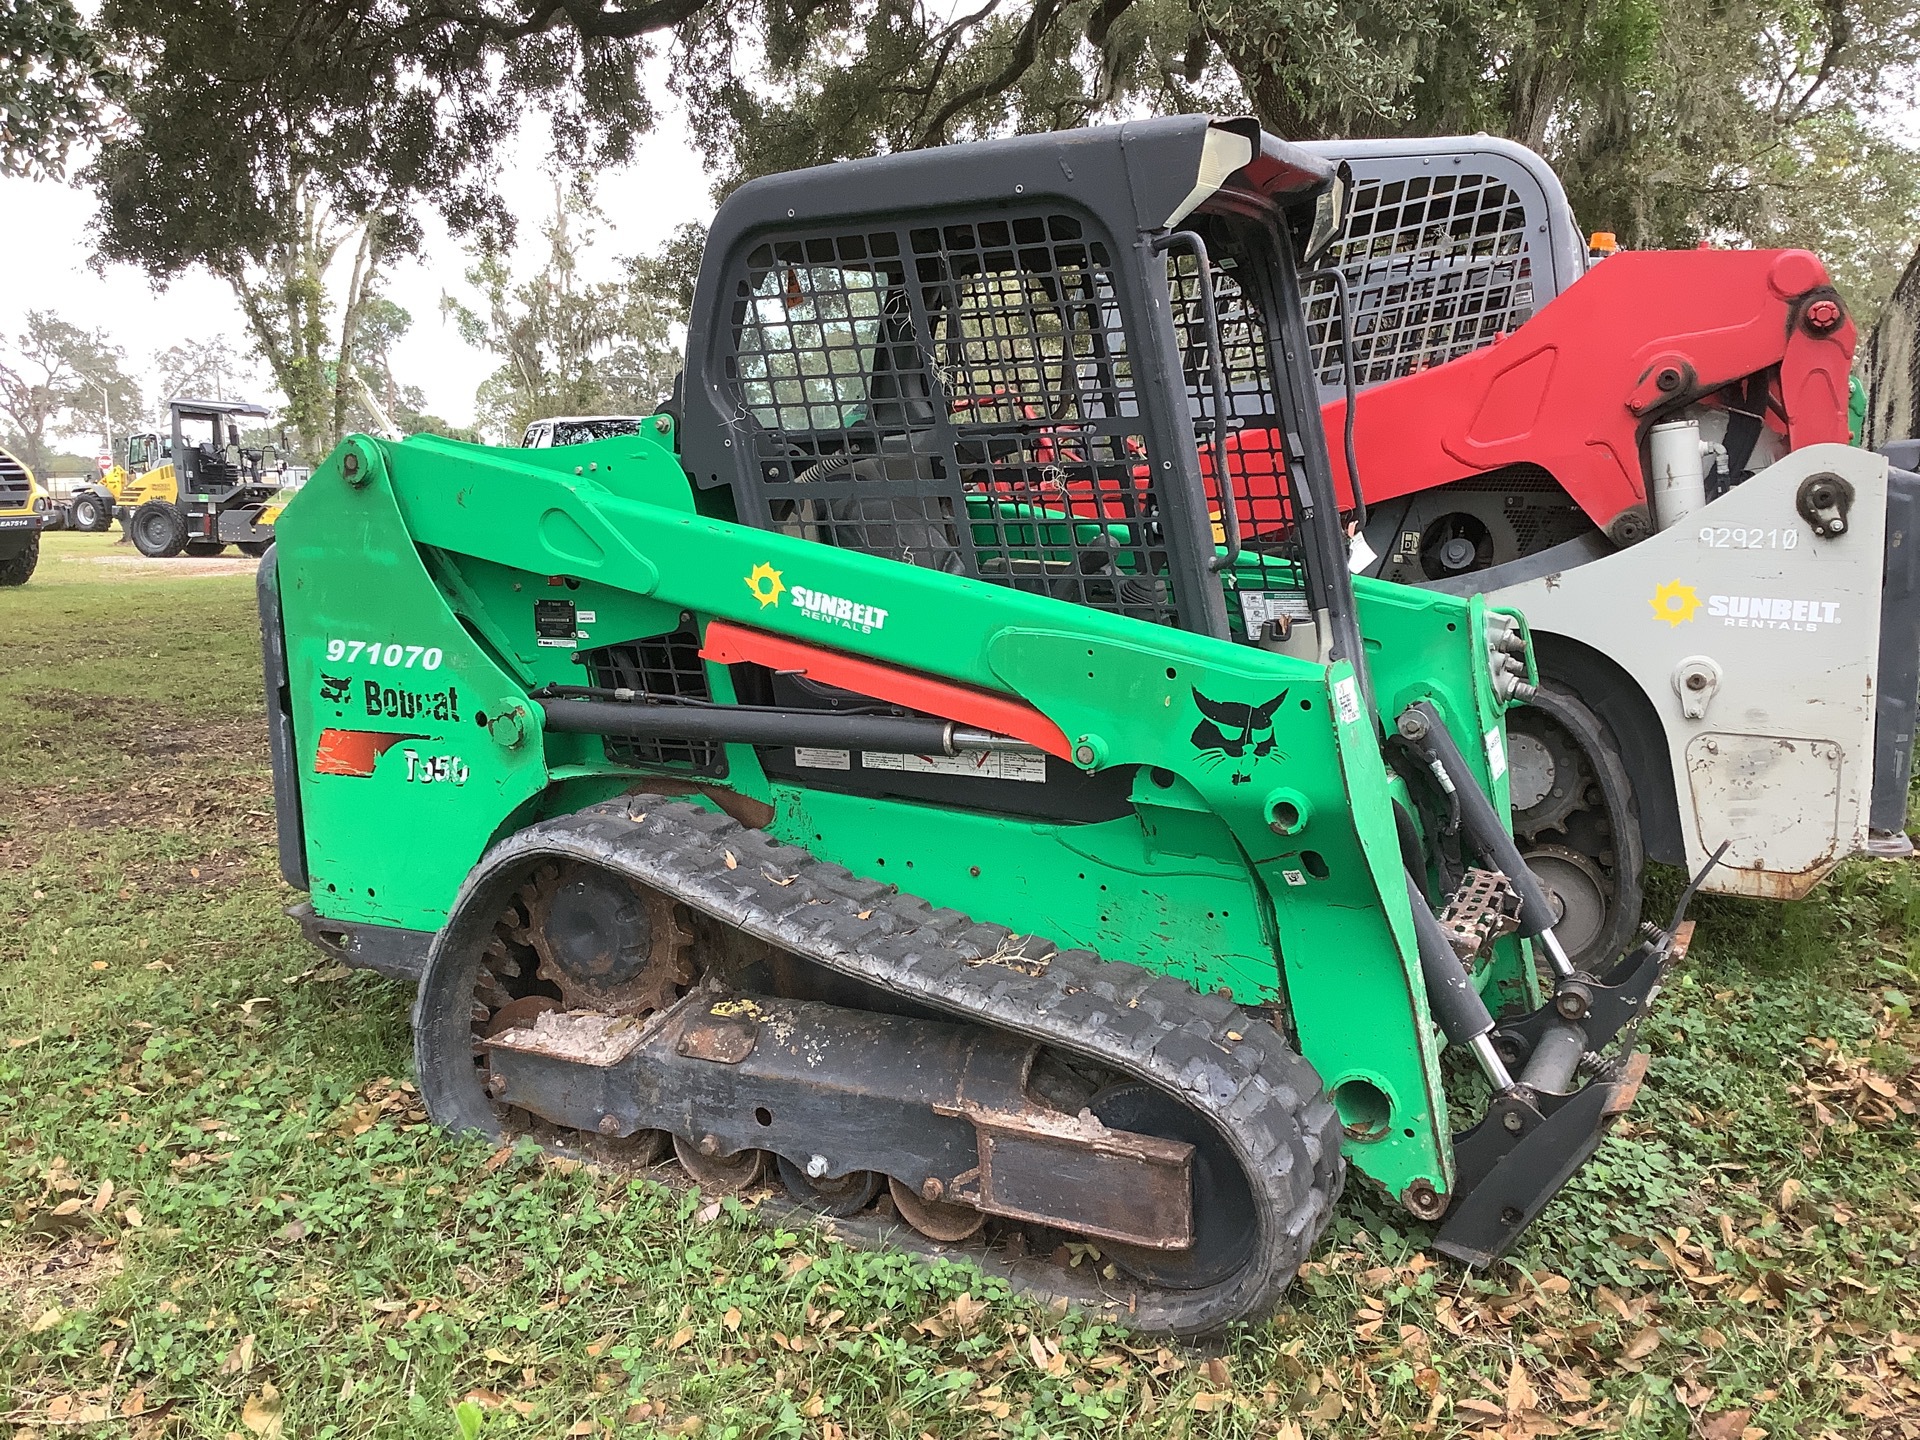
(1320, 250, 1855, 556)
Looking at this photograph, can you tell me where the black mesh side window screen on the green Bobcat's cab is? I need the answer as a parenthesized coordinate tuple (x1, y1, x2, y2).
(726, 213, 1177, 622)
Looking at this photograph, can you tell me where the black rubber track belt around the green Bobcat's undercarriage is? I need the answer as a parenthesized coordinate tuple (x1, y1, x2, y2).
(437, 795, 1344, 1334)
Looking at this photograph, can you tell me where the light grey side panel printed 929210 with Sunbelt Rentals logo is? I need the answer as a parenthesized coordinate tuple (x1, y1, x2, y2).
(1490, 445, 1887, 899)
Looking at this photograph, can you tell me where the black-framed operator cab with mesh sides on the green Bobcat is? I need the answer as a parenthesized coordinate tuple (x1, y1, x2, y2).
(684, 115, 1361, 664)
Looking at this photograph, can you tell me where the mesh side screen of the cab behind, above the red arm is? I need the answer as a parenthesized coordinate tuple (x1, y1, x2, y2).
(1306, 171, 1546, 388)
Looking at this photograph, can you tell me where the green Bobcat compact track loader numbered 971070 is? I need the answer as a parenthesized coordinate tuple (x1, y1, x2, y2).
(261, 117, 1704, 1332)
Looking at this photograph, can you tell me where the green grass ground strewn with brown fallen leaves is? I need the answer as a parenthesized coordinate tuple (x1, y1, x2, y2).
(0, 536, 1920, 1440)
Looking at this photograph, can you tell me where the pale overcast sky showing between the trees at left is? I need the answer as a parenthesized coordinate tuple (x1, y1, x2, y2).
(0, 84, 712, 453)
